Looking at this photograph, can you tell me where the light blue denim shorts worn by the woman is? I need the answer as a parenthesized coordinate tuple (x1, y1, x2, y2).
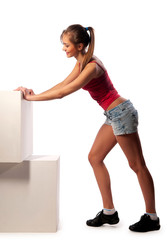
(104, 100, 138, 135)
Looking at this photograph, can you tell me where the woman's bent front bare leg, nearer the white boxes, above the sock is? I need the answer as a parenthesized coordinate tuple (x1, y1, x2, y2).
(88, 124, 117, 209)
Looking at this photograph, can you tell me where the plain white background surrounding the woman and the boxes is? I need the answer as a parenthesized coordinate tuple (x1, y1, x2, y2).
(0, 0, 167, 240)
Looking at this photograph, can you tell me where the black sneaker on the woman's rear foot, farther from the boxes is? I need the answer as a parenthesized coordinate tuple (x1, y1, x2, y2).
(129, 214, 160, 232)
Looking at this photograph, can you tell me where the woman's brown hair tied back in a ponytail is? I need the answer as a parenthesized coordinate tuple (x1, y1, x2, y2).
(60, 24, 95, 71)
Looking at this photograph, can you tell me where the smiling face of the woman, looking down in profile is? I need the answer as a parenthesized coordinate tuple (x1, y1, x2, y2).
(62, 34, 79, 58)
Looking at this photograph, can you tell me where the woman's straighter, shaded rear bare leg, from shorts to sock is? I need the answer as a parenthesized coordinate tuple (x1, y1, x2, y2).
(116, 132, 156, 213)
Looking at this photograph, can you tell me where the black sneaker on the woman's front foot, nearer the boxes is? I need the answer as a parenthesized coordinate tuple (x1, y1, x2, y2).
(86, 210, 119, 227)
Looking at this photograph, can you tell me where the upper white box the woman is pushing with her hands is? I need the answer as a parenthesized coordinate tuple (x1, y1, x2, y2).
(0, 91, 33, 162)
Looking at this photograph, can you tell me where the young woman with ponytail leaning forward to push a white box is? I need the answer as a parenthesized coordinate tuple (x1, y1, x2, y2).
(16, 24, 160, 232)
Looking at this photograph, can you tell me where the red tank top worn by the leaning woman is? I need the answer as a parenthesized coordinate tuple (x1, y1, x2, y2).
(82, 61, 120, 110)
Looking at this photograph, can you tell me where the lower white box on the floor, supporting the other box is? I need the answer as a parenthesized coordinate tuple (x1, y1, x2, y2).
(0, 156, 60, 232)
